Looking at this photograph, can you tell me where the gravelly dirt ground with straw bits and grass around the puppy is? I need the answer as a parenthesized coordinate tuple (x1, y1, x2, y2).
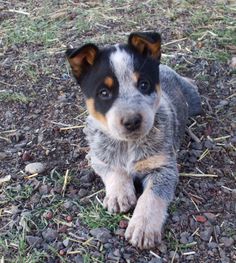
(0, 0, 236, 263)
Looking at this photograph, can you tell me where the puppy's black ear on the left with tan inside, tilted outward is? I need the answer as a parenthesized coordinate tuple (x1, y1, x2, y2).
(66, 44, 99, 82)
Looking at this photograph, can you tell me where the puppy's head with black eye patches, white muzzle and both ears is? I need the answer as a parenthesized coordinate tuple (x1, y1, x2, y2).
(67, 33, 161, 141)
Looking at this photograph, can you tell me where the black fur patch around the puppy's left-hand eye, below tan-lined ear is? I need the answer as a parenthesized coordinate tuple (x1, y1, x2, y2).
(80, 47, 119, 114)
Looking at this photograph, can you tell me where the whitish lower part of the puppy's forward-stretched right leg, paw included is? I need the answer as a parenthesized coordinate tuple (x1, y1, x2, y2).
(125, 185, 168, 249)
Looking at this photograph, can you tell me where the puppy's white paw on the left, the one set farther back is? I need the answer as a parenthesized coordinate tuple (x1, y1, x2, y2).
(103, 188, 137, 213)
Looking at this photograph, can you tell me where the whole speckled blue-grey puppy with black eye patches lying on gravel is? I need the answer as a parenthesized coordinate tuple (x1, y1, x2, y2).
(66, 32, 201, 249)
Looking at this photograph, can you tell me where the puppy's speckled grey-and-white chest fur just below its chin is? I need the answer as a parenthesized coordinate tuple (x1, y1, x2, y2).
(84, 120, 165, 172)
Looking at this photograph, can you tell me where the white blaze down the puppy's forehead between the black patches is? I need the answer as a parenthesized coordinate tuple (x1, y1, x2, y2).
(110, 46, 134, 92)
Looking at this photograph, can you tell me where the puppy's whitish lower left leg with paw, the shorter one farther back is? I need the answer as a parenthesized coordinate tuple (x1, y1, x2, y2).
(101, 170, 137, 213)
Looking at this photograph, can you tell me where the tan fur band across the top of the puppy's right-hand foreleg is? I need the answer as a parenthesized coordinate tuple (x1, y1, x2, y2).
(134, 154, 167, 172)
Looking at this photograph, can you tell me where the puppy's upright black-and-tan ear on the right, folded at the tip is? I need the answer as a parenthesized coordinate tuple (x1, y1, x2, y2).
(128, 32, 161, 60)
